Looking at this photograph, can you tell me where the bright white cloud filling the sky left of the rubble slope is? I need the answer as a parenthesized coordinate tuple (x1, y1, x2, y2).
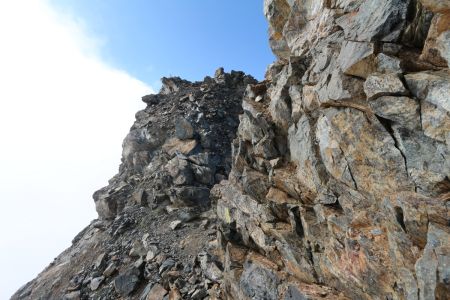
(0, 0, 151, 299)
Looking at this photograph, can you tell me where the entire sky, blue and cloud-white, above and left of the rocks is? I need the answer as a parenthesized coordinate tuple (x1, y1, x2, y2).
(0, 0, 274, 299)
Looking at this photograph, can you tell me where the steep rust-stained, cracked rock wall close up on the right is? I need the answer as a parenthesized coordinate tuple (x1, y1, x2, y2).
(212, 0, 450, 299)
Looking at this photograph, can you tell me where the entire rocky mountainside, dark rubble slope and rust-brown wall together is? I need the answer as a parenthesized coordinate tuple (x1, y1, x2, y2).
(12, 0, 450, 300)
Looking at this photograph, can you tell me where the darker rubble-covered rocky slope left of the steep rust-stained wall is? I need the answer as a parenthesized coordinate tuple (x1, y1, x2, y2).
(12, 69, 256, 299)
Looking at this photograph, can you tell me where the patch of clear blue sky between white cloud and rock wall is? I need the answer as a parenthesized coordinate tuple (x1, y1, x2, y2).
(51, 0, 274, 86)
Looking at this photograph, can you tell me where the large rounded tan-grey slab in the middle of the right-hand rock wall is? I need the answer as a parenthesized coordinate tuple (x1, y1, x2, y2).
(316, 109, 412, 195)
